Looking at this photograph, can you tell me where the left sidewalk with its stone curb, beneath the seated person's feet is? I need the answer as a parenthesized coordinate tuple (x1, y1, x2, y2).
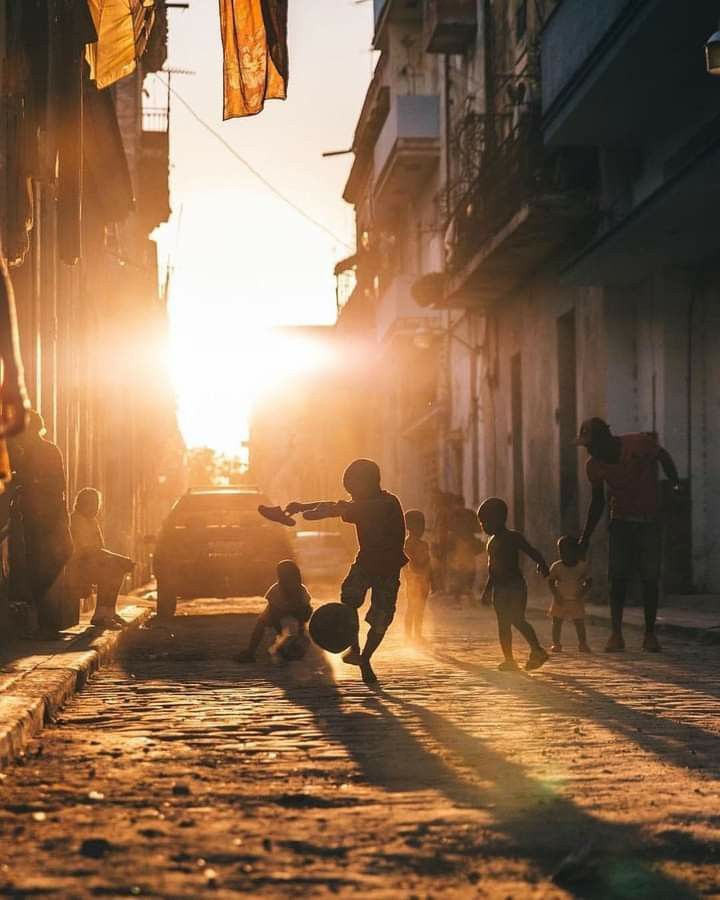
(0, 596, 154, 767)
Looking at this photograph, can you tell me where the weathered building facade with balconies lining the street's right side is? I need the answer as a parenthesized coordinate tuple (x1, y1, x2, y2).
(339, 0, 720, 595)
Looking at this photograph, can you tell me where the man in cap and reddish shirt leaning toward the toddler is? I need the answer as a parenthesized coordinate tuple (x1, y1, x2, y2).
(577, 418, 680, 653)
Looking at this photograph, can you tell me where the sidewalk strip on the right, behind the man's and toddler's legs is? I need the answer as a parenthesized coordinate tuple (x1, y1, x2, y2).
(529, 594, 720, 644)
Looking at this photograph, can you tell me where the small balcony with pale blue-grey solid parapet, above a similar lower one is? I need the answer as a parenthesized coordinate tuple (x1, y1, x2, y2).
(374, 95, 440, 219)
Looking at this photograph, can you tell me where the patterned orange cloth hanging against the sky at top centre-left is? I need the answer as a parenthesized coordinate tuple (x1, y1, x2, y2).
(220, 0, 288, 119)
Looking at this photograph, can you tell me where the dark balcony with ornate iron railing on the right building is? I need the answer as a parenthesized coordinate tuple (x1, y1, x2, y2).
(442, 113, 597, 307)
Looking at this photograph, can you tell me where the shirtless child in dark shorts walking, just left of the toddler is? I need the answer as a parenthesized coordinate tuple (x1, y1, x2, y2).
(478, 497, 550, 672)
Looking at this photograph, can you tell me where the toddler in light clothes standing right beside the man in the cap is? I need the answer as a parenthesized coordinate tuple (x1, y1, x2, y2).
(549, 535, 592, 653)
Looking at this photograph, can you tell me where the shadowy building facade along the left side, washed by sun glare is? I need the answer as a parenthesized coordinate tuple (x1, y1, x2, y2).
(0, 0, 181, 632)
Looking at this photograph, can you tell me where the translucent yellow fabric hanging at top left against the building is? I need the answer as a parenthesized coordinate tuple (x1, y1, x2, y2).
(86, 0, 155, 88)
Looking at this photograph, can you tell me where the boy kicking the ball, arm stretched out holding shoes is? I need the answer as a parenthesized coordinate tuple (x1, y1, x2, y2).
(261, 459, 407, 684)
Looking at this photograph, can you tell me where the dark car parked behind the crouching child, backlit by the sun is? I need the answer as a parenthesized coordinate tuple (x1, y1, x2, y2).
(153, 487, 294, 618)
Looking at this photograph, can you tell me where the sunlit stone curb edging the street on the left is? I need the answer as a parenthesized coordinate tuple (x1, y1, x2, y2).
(0, 609, 151, 769)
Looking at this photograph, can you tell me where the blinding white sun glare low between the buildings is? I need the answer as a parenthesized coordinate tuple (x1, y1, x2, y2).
(170, 304, 332, 457)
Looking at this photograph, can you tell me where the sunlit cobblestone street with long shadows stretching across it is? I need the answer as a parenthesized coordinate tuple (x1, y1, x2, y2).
(0, 601, 720, 900)
